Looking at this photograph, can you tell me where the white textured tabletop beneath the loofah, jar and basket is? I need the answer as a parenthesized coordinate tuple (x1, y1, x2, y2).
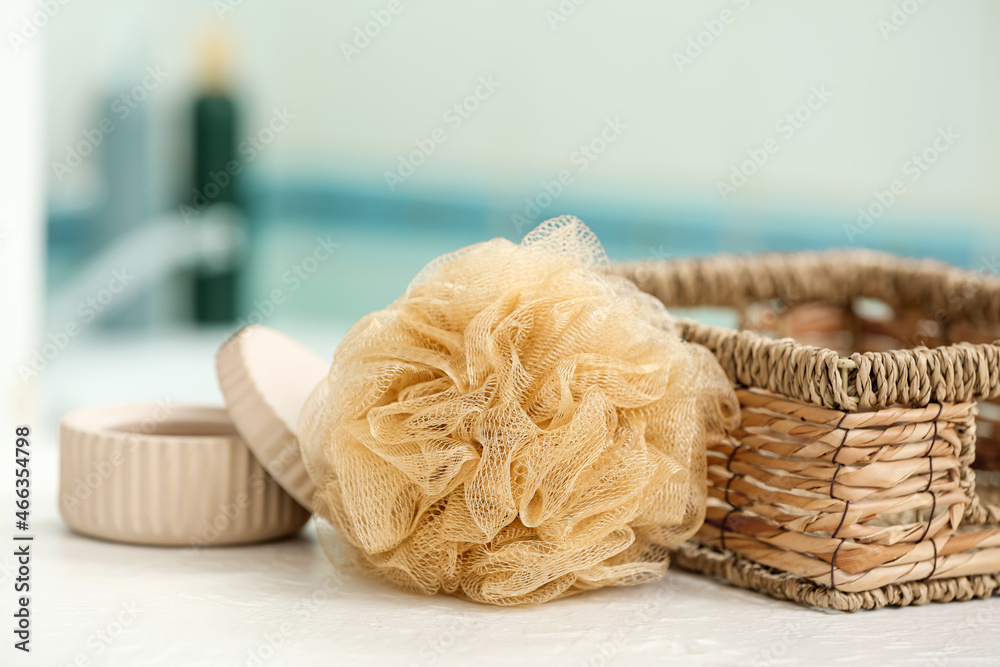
(9, 332, 1000, 667)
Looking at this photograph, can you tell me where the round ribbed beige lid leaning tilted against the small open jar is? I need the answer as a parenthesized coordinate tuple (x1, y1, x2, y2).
(215, 325, 330, 510)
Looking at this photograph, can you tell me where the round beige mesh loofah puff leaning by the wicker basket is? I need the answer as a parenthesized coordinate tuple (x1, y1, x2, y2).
(300, 217, 738, 605)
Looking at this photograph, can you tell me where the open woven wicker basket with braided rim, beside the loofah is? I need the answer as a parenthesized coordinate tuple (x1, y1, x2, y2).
(616, 251, 1000, 610)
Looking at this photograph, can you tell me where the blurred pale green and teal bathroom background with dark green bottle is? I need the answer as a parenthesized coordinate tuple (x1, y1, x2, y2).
(0, 0, 1000, 428)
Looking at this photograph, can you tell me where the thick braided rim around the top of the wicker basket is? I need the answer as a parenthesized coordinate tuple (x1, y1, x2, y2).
(612, 249, 1000, 411)
